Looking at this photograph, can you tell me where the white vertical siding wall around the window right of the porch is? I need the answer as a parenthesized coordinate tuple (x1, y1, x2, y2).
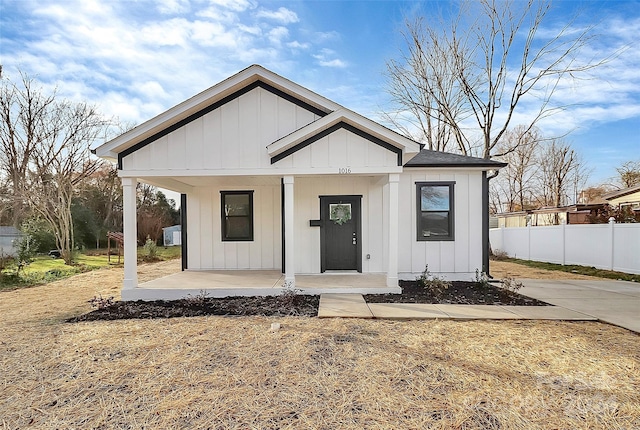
(398, 169, 482, 280)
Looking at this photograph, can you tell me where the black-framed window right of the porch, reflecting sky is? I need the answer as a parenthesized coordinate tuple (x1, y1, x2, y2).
(416, 182, 455, 241)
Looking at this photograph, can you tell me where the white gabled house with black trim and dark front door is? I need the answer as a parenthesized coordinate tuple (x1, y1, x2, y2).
(95, 65, 505, 299)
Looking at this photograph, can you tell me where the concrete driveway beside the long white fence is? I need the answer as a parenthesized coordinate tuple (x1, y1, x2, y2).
(518, 279, 640, 333)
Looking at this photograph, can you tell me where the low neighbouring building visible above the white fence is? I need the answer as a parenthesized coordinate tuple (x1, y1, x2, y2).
(495, 203, 604, 227)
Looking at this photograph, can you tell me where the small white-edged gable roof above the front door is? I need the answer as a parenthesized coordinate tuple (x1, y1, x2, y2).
(267, 108, 420, 166)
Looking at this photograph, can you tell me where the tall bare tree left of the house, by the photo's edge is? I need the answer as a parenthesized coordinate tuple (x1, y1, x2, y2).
(0, 73, 109, 264)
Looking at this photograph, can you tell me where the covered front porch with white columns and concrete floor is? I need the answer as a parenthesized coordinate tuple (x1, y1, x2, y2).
(117, 172, 400, 300)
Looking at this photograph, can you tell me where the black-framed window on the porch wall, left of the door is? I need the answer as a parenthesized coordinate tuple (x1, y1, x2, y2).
(220, 191, 253, 241)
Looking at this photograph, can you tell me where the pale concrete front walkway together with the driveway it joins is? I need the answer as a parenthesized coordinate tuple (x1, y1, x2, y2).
(318, 279, 640, 332)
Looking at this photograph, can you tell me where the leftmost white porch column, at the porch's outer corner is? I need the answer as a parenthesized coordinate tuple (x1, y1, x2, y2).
(122, 178, 138, 290)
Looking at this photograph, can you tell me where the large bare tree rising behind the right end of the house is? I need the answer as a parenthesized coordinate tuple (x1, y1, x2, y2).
(387, 0, 604, 158)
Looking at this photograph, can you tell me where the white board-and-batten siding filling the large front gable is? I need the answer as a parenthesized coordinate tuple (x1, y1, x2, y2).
(123, 88, 319, 176)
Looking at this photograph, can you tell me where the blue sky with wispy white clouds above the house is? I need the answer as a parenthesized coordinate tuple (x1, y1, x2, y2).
(0, 0, 640, 184)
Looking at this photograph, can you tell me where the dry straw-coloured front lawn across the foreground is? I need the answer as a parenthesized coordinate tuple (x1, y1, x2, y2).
(0, 256, 640, 429)
